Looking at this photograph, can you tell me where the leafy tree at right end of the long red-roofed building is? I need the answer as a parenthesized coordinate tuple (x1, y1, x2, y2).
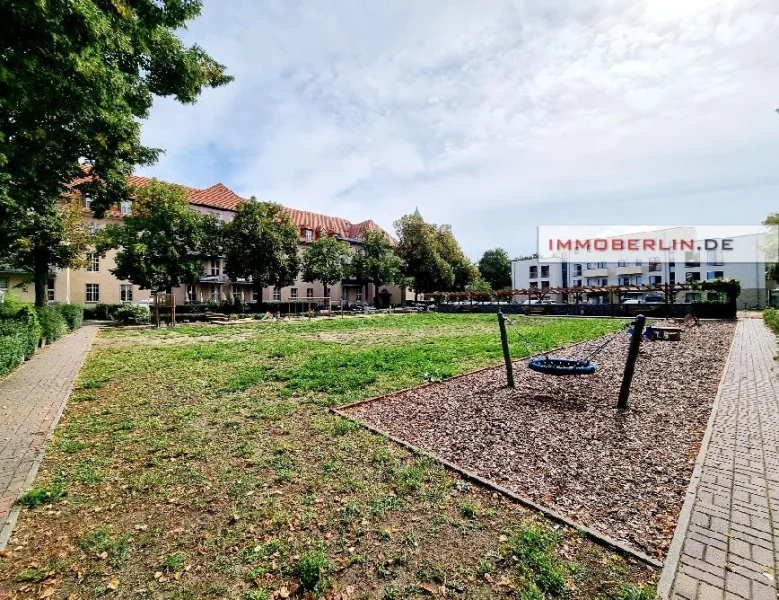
(395, 215, 478, 293)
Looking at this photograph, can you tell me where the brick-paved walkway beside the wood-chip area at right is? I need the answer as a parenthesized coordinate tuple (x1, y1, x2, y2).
(658, 319, 779, 600)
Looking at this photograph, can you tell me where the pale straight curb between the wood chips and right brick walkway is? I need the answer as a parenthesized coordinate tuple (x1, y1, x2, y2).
(657, 323, 738, 600)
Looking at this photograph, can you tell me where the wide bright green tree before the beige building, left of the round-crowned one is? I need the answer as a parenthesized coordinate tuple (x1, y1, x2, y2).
(96, 180, 220, 293)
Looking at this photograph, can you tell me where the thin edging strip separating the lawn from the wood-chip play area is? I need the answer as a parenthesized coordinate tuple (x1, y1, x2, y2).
(330, 406, 663, 569)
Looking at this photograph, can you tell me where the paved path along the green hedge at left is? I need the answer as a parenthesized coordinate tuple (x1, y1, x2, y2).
(0, 326, 97, 548)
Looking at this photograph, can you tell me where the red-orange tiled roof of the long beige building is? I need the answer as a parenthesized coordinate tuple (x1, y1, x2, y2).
(71, 168, 395, 243)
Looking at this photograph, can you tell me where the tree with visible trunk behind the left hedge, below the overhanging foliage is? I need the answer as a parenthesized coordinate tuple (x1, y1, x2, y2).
(4, 197, 92, 306)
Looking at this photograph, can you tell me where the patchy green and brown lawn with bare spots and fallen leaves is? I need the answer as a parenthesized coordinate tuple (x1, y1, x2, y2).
(0, 315, 657, 600)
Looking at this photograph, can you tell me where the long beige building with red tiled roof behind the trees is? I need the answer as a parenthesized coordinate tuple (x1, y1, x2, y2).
(0, 176, 413, 306)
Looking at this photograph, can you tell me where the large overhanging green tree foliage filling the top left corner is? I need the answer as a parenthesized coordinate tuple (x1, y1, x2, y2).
(0, 0, 231, 304)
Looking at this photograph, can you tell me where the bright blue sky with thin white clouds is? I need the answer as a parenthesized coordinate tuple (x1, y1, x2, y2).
(140, 0, 779, 260)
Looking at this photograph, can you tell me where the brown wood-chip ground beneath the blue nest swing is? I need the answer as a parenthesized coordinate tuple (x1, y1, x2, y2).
(349, 322, 735, 558)
